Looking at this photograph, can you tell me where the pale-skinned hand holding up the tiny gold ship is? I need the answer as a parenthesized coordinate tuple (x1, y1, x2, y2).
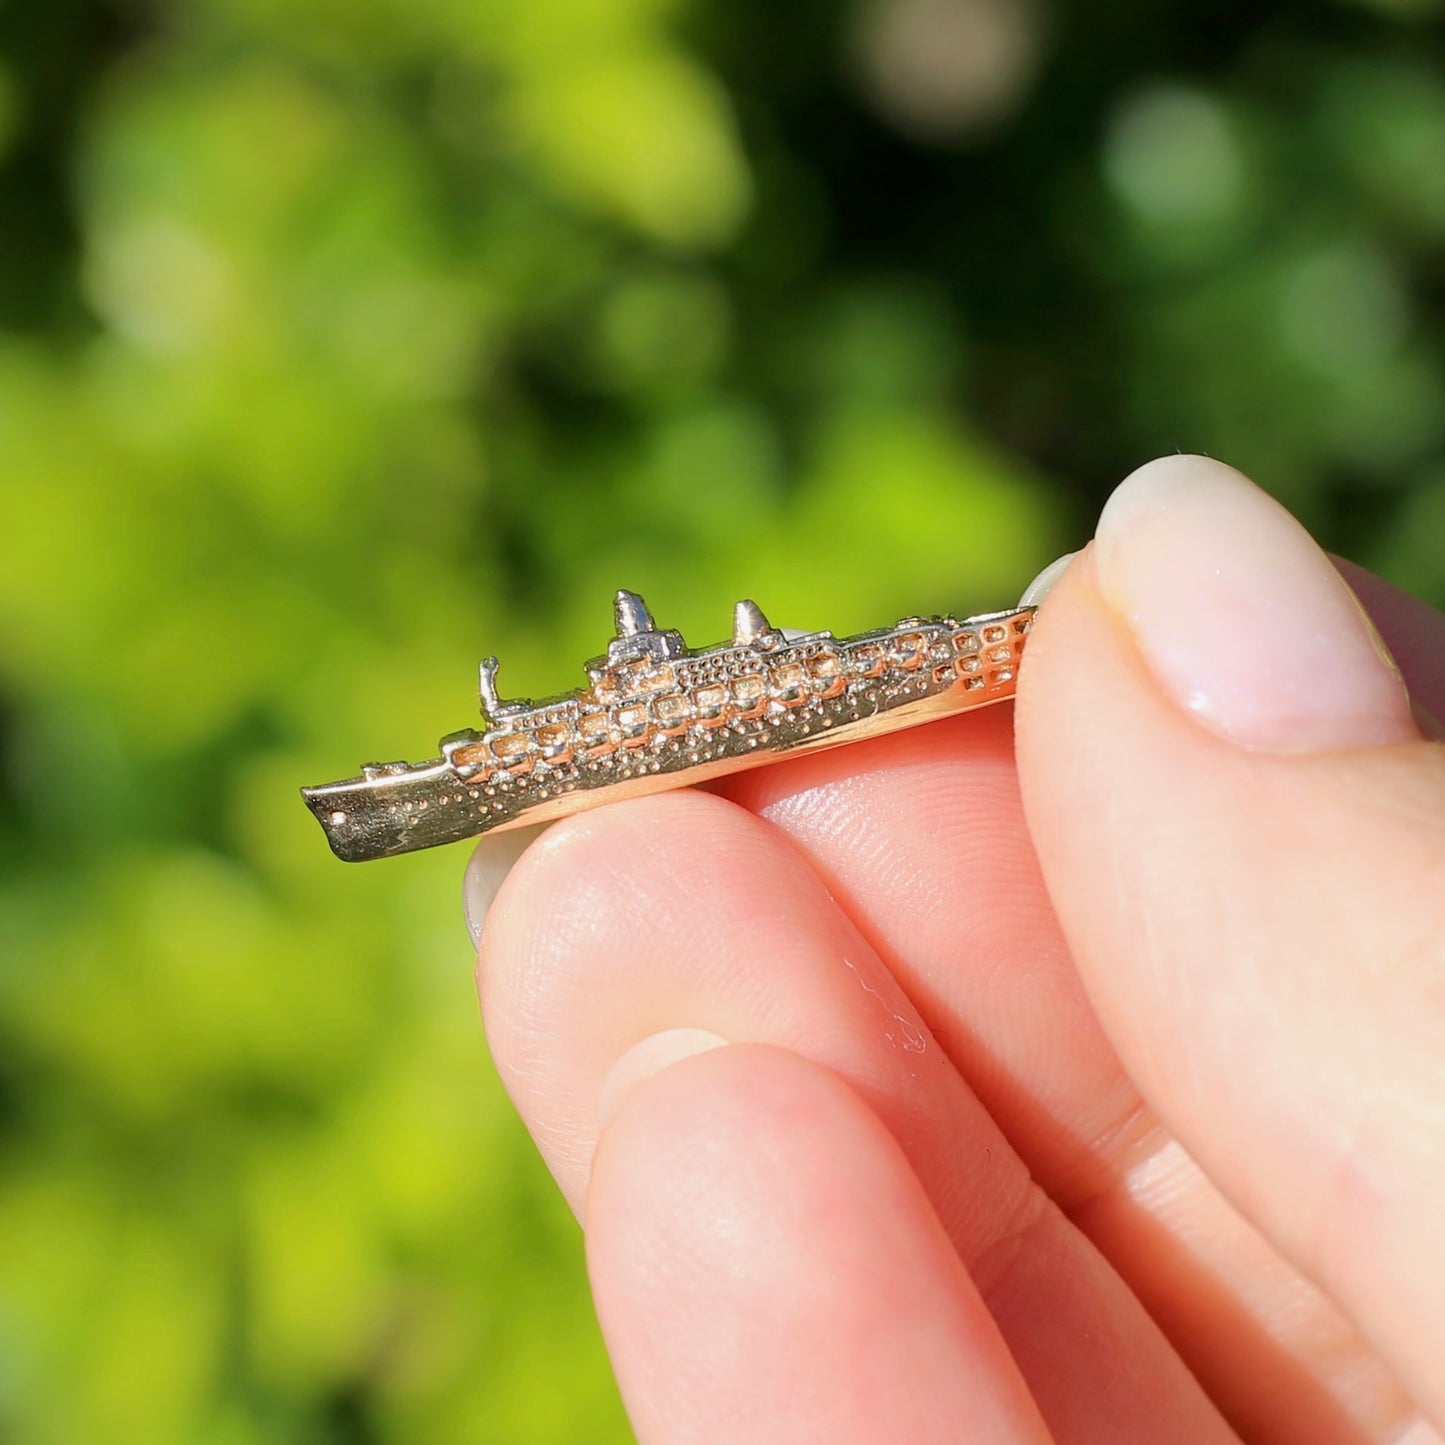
(471, 458, 1445, 1445)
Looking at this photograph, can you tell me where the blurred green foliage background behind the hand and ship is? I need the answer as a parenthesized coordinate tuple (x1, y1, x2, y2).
(0, 0, 1445, 1445)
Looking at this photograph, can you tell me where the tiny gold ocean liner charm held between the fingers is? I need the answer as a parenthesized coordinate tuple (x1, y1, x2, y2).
(302, 591, 1033, 863)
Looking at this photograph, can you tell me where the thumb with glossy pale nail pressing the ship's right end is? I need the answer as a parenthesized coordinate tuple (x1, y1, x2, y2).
(1017, 457, 1445, 1422)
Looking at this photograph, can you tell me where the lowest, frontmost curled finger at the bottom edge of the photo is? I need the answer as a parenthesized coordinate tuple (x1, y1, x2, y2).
(587, 1043, 1048, 1445)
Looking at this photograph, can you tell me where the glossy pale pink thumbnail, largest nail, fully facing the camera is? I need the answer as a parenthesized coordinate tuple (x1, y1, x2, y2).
(1094, 457, 1419, 753)
